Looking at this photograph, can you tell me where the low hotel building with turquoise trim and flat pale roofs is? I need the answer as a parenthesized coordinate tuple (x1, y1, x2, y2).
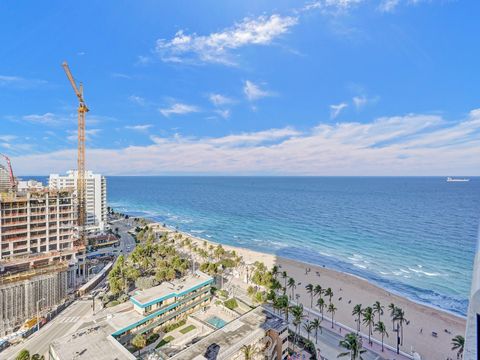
(49, 272, 213, 360)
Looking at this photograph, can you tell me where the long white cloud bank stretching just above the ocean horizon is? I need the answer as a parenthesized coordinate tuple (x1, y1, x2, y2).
(12, 110, 480, 175)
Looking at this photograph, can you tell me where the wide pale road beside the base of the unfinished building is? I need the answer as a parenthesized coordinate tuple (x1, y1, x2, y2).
(0, 300, 92, 360)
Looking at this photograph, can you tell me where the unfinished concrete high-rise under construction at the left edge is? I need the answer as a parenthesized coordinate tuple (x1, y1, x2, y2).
(0, 156, 85, 336)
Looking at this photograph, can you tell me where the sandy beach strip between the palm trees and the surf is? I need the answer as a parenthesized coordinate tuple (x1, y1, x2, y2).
(168, 228, 466, 360)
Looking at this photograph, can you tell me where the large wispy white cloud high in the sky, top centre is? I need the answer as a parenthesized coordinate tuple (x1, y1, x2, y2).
(155, 14, 298, 65)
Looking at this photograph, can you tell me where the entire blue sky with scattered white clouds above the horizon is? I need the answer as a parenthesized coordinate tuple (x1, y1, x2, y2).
(0, 0, 480, 176)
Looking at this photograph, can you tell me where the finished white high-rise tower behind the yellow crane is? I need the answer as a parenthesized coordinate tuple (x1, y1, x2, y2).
(48, 170, 107, 231)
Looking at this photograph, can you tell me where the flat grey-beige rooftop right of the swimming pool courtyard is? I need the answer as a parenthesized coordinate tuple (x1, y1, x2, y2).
(171, 306, 287, 360)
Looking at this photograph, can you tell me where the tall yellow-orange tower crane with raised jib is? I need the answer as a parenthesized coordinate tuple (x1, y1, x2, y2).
(62, 61, 89, 245)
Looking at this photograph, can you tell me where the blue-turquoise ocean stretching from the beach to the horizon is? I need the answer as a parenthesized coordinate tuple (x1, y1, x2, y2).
(108, 177, 480, 314)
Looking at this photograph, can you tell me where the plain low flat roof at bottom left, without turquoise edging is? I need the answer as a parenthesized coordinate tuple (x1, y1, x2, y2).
(50, 322, 136, 360)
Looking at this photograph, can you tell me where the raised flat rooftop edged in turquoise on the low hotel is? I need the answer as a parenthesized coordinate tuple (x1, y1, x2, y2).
(130, 271, 213, 308)
